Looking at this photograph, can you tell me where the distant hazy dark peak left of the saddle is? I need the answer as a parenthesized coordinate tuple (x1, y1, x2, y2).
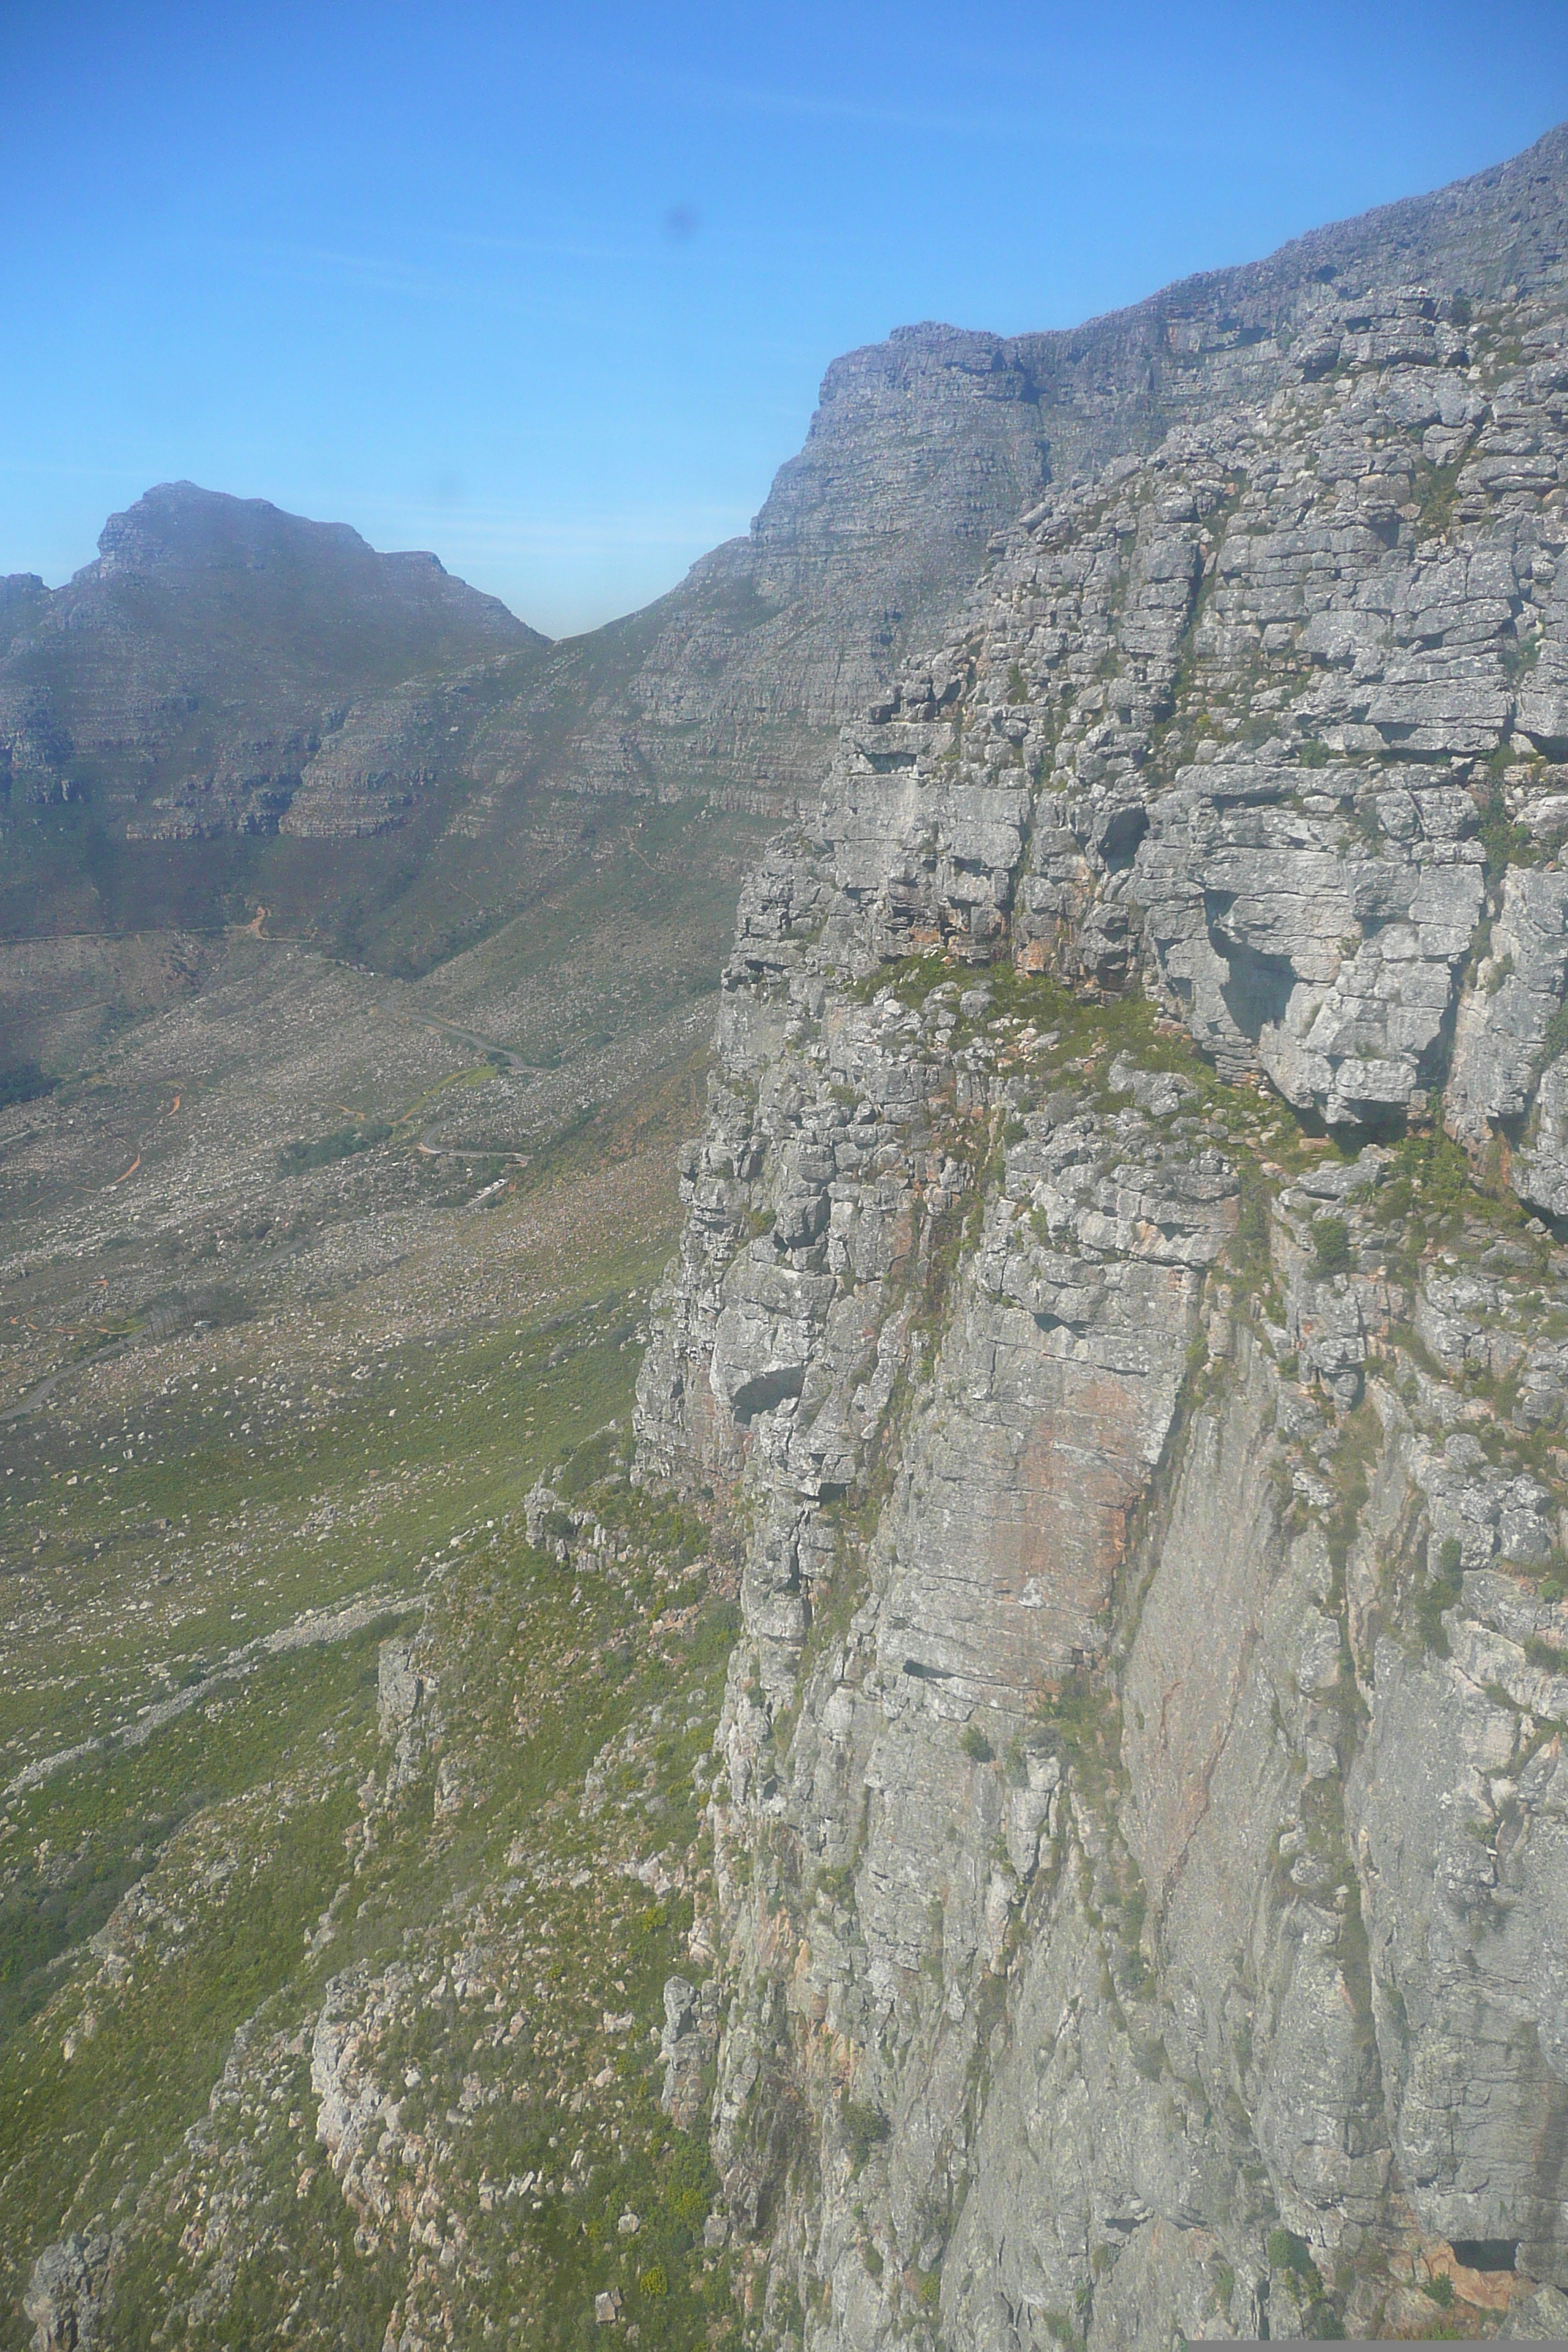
(0, 482, 548, 840)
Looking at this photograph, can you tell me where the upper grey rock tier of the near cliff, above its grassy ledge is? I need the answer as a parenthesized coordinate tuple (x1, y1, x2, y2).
(766, 275, 1568, 1176)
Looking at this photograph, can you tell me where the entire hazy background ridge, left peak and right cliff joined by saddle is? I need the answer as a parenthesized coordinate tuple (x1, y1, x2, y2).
(12, 129, 1568, 902)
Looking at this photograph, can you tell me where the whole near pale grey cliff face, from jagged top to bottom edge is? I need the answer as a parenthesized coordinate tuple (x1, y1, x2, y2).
(637, 267, 1568, 2352)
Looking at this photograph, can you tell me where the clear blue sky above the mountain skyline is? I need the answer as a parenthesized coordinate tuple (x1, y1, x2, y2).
(0, 0, 1568, 635)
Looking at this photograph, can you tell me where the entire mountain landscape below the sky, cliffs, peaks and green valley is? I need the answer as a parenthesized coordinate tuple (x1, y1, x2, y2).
(0, 132, 1568, 2352)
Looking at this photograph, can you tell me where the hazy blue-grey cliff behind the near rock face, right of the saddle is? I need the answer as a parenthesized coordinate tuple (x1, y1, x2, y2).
(540, 129, 1568, 818)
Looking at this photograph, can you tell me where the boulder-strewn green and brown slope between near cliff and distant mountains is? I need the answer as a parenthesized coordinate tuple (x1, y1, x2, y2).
(0, 766, 780, 2348)
